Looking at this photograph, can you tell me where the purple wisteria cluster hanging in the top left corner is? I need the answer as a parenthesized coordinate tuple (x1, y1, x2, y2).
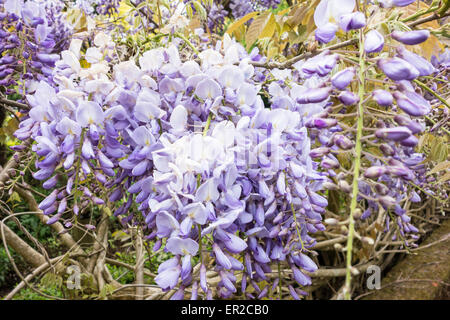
(0, 0, 71, 94)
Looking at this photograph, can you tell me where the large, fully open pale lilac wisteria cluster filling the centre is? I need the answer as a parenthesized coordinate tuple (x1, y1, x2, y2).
(16, 29, 334, 298)
